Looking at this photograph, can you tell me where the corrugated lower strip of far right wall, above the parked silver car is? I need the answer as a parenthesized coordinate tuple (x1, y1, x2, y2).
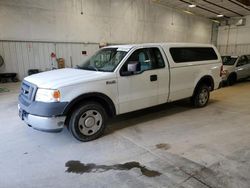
(218, 44, 250, 55)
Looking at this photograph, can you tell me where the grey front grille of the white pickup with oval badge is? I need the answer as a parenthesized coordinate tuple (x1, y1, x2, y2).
(19, 81, 37, 106)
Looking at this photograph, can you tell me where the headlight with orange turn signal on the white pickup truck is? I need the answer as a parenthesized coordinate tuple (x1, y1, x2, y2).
(35, 89, 61, 102)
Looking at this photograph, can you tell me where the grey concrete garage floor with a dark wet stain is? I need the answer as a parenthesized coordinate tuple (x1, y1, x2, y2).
(0, 81, 250, 188)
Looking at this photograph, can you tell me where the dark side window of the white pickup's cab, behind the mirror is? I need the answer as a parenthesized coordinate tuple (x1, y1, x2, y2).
(121, 48, 165, 73)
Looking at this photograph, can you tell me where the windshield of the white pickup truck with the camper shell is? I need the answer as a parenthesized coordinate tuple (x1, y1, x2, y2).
(78, 48, 128, 72)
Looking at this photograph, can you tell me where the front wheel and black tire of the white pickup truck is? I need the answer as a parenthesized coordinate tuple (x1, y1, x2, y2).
(68, 102, 107, 142)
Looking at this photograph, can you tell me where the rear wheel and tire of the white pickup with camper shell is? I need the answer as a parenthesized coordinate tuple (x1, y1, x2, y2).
(191, 85, 210, 108)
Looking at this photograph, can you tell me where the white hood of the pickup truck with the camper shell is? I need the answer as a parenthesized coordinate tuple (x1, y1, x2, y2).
(24, 68, 115, 89)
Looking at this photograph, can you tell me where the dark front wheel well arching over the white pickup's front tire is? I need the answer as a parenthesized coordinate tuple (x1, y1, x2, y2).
(63, 93, 116, 125)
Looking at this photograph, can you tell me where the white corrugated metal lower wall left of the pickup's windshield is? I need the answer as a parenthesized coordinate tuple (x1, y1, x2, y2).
(0, 41, 99, 79)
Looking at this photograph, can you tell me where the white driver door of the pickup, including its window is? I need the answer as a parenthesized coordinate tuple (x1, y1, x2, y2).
(118, 48, 165, 113)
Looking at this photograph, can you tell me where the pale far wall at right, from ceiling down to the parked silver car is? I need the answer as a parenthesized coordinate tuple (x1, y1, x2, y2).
(218, 16, 250, 55)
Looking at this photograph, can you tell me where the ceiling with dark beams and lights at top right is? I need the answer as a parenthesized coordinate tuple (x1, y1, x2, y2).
(153, 0, 250, 19)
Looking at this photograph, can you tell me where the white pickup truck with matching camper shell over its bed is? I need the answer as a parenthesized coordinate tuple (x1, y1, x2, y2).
(18, 43, 222, 141)
